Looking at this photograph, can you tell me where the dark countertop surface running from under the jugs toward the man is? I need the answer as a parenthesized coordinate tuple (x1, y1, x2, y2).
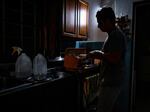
(0, 65, 99, 96)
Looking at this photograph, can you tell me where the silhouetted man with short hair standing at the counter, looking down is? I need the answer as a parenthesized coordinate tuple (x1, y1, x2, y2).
(87, 7, 126, 112)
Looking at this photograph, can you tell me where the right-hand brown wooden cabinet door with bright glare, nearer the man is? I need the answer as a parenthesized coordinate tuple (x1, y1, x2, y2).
(78, 0, 89, 38)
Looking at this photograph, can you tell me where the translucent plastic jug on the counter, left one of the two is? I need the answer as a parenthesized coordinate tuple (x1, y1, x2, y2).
(15, 53, 32, 78)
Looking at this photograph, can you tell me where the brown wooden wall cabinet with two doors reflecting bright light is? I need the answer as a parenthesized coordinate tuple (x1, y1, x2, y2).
(62, 0, 89, 39)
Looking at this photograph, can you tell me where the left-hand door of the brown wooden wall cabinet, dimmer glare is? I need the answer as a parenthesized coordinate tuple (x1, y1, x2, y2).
(63, 0, 77, 37)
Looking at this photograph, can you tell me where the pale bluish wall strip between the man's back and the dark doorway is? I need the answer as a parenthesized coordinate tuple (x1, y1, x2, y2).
(115, 0, 133, 112)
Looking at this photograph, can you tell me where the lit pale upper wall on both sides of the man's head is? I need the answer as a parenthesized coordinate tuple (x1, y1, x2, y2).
(86, 0, 135, 41)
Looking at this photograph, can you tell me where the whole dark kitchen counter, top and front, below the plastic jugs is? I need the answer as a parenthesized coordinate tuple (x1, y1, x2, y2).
(0, 65, 99, 112)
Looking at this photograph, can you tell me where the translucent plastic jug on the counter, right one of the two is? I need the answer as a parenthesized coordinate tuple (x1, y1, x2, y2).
(33, 53, 47, 80)
